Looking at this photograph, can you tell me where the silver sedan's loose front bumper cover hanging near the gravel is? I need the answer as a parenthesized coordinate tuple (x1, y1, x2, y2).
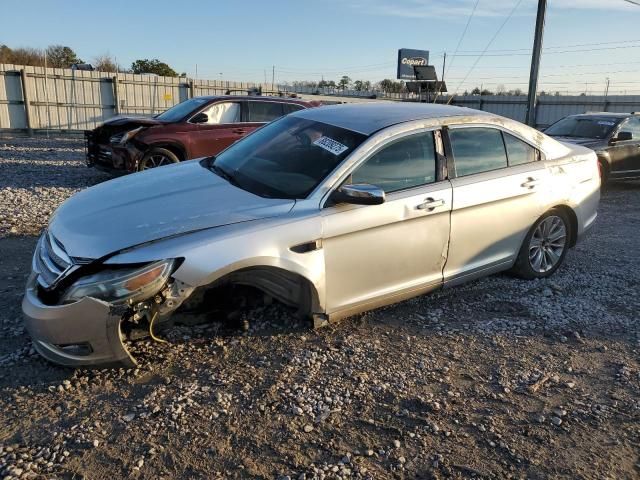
(22, 278, 136, 368)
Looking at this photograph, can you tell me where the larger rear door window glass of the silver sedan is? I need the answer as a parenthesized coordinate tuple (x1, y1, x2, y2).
(449, 128, 507, 177)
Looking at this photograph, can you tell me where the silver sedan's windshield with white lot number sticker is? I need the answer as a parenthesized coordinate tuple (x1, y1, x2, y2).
(211, 117, 366, 199)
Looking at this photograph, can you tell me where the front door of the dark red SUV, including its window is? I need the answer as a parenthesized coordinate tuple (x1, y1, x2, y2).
(190, 101, 245, 158)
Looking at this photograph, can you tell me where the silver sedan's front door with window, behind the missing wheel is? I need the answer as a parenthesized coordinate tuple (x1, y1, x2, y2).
(322, 131, 451, 314)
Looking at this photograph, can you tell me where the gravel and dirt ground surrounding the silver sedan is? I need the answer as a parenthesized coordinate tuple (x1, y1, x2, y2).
(0, 139, 640, 480)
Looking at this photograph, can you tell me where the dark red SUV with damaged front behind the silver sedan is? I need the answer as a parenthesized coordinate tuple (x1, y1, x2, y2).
(85, 95, 320, 173)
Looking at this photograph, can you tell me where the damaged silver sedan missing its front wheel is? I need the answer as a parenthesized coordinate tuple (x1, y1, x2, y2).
(22, 102, 600, 366)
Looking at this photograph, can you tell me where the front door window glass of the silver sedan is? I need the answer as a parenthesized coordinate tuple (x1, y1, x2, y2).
(351, 132, 436, 193)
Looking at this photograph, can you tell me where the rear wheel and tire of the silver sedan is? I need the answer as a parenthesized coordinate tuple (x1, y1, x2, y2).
(511, 208, 572, 280)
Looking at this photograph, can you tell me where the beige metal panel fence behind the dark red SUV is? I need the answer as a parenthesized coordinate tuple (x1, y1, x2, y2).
(0, 64, 272, 131)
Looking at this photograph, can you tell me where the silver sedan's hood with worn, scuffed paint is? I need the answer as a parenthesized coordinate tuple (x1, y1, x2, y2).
(49, 160, 295, 259)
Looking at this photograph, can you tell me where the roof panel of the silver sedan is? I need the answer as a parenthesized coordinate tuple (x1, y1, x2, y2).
(292, 101, 486, 135)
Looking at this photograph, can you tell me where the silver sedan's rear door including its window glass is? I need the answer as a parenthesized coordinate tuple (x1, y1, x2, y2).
(444, 126, 550, 284)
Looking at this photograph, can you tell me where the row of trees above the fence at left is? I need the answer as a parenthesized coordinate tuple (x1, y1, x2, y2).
(0, 45, 181, 77)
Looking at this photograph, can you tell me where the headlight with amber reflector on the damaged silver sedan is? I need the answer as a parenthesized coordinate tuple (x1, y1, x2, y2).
(62, 260, 174, 304)
